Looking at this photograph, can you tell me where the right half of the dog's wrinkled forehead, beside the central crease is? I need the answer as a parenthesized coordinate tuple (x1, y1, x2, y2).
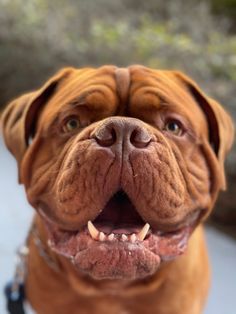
(130, 68, 208, 134)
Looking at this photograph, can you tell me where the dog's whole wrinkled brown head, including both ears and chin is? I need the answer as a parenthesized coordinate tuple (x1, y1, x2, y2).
(3, 66, 233, 279)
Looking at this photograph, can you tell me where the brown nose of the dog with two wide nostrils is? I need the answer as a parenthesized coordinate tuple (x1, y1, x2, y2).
(93, 117, 152, 148)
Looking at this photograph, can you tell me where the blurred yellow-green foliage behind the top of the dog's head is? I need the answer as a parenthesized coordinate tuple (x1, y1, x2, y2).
(0, 0, 236, 111)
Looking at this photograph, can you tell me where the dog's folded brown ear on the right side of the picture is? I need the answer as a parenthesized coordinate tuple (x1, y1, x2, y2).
(174, 72, 234, 190)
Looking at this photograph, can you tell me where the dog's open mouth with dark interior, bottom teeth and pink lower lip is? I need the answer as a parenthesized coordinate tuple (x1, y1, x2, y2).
(42, 191, 198, 280)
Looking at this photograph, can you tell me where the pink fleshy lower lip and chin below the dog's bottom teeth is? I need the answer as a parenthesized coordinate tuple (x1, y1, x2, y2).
(42, 207, 193, 280)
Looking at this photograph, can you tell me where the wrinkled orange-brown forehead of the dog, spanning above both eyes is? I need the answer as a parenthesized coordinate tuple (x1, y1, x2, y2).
(39, 66, 208, 134)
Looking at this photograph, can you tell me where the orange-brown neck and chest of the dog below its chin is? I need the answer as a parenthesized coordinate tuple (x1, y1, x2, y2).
(26, 217, 209, 314)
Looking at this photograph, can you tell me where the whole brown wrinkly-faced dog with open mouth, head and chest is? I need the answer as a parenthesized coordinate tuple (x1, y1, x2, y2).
(3, 66, 233, 314)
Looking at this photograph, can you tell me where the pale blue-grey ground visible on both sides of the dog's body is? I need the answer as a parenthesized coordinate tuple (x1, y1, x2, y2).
(0, 139, 236, 314)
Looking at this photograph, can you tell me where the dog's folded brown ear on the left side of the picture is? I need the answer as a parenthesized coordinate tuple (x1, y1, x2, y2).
(2, 68, 72, 180)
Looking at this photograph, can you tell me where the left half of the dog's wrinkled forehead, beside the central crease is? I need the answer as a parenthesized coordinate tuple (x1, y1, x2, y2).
(40, 67, 118, 121)
